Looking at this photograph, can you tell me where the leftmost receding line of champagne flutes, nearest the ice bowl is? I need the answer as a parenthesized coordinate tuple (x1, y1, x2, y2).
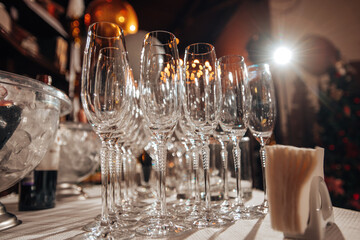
(79, 22, 146, 239)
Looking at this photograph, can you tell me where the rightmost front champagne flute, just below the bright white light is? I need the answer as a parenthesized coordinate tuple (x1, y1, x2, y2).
(247, 63, 276, 214)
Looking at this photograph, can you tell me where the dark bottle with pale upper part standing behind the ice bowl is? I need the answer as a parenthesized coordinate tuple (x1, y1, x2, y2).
(19, 75, 60, 211)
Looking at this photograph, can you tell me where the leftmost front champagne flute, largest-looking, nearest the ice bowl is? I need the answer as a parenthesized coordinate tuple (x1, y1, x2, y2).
(80, 22, 133, 239)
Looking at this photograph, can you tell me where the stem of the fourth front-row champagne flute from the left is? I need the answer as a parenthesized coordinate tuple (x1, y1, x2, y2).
(232, 136, 244, 207)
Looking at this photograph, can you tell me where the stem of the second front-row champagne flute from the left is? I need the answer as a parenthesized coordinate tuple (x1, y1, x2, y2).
(157, 142, 167, 217)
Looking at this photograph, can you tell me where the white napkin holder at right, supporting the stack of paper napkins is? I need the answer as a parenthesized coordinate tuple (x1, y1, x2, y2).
(284, 176, 334, 240)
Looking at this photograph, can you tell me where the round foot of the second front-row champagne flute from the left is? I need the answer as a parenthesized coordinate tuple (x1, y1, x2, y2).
(135, 218, 191, 238)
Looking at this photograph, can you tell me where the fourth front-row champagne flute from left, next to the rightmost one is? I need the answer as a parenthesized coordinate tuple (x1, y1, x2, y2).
(218, 55, 256, 220)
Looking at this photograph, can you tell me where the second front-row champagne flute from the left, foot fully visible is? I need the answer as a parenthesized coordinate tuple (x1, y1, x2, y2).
(136, 31, 189, 237)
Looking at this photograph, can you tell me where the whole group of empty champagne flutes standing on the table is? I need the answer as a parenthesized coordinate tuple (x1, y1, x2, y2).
(79, 22, 276, 239)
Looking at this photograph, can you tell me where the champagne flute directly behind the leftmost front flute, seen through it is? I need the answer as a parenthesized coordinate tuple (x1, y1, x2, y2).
(92, 47, 137, 236)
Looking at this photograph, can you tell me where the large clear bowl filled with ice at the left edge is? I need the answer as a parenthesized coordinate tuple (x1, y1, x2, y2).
(0, 71, 71, 191)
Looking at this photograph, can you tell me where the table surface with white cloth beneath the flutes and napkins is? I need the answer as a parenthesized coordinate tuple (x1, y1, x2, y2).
(0, 186, 360, 240)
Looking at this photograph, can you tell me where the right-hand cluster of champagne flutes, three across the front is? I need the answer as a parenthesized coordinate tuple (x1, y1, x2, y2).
(180, 43, 276, 227)
